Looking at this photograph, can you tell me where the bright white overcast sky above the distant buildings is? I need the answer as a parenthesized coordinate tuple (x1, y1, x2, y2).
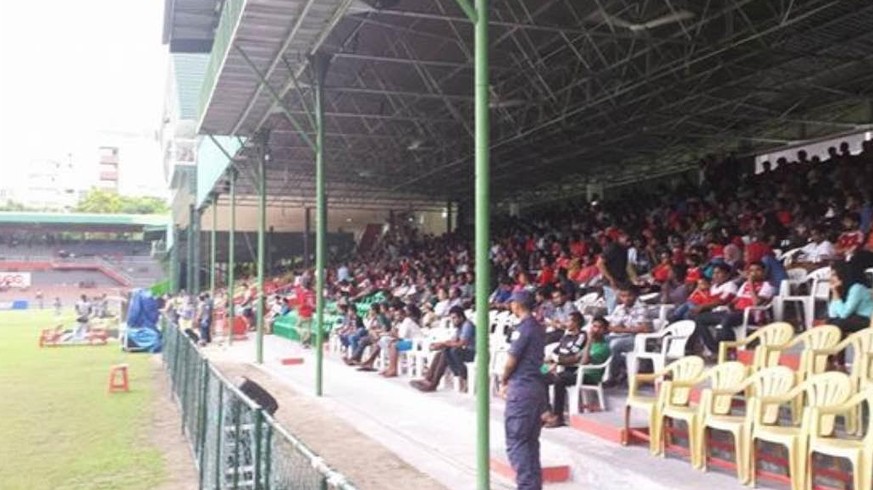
(0, 0, 167, 194)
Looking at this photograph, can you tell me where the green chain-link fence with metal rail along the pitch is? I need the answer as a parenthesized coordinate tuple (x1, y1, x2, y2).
(163, 322, 356, 490)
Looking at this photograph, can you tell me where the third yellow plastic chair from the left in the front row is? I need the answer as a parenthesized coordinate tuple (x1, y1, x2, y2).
(695, 366, 796, 484)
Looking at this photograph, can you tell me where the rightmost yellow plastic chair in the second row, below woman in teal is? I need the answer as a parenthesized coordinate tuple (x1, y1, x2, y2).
(808, 328, 873, 434)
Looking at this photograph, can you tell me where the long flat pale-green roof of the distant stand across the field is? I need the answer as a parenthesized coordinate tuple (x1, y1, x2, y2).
(0, 211, 170, 231)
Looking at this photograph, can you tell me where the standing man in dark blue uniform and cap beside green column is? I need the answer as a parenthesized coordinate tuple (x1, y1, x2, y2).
(500, 291, 547, 490)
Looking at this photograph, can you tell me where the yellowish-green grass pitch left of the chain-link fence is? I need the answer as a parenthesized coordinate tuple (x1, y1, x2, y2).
(0, 311, 165, 490)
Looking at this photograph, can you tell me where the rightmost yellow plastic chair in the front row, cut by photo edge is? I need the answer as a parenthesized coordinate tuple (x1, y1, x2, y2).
(806, 387, 873, 490)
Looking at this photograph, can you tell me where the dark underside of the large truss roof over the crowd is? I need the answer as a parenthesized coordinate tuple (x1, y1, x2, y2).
(170, 0, 873, 207)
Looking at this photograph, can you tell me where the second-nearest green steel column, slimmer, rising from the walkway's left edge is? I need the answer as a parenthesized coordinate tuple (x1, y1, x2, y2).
(314, 55, 329, 396)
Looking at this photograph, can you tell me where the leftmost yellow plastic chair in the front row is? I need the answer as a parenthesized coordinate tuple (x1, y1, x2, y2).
(623, 356, 703, 455)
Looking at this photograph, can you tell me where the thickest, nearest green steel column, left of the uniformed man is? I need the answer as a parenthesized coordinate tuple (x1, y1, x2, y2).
(474, 0, 491, 490)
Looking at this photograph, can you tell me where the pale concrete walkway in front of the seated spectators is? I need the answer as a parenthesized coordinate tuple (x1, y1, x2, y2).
(206, 336, 745, 490)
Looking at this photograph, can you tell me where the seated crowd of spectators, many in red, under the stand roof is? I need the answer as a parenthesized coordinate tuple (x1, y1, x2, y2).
(249, 142, 873, 425)
